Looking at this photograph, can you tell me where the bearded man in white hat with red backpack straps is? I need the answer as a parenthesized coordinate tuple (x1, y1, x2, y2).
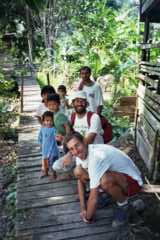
(53, 91, 104, 171)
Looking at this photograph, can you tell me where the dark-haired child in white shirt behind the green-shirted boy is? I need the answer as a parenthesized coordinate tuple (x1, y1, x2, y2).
(36, 85, 55, 124)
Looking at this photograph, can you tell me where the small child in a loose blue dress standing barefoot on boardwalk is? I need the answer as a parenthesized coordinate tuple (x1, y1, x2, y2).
(38, 111, 59, 178)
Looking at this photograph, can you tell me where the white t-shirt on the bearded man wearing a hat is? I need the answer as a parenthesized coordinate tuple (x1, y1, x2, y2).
(73, 113, 104, 144)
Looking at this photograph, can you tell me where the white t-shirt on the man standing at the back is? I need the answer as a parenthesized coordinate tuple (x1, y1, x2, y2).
(83, 82, 103, 112)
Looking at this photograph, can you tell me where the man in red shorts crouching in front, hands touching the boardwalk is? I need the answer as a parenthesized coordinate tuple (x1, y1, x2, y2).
(65, 132, 143, 227)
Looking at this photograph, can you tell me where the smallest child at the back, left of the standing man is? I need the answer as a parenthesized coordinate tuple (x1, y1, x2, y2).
(57, 85, 69, 115)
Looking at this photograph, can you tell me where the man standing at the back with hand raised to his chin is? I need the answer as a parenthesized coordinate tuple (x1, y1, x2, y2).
(78, 66, 103, 114)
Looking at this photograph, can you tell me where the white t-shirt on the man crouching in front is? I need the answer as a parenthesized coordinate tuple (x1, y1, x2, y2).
(76, 144, 143, 189)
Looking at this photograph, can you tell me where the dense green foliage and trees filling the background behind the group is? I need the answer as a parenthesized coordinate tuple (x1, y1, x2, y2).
(0, 0, 138, 98)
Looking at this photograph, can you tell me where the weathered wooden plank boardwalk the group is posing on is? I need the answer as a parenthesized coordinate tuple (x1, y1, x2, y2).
(16, 78, 128, 240)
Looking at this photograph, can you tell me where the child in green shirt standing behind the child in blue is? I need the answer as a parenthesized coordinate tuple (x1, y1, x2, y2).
(47, 94, 72, 143)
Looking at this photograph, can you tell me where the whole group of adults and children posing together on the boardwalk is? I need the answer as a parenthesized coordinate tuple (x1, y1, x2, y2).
(36, 67, 143, 227)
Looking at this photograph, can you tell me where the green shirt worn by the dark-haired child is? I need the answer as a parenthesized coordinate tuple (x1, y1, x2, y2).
(54, 111, 69, 136)
